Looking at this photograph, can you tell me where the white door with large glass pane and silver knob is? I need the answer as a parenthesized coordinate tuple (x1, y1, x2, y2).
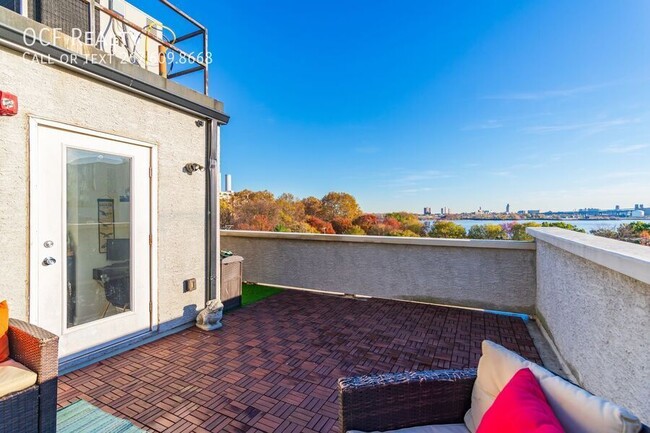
(31, 126, 151, 357)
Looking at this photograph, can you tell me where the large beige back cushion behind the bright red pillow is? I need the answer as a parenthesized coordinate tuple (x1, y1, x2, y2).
(465, 341, 641, 433)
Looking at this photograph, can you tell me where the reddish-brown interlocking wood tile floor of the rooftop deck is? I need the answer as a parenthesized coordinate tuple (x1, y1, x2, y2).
(58, 291, 540, 432)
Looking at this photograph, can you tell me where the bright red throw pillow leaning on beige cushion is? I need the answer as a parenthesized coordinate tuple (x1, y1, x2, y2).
(476, 368, 564, 433)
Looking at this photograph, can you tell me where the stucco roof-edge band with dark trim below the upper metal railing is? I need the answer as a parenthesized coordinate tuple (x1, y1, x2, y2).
(0, 7, 229, 123)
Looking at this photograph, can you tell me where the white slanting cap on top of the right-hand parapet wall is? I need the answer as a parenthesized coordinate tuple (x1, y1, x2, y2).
(526, 227, 650, 284)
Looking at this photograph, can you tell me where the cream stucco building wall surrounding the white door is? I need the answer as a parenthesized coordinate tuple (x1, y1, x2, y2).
(0, 43, 206, 328)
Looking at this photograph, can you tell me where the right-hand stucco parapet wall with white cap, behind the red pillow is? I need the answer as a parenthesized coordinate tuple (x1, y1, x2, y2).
(529, 229, 650, 424)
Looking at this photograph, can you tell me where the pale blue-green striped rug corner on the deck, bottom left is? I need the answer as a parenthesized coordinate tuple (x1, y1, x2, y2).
(56, 400, 143, 433)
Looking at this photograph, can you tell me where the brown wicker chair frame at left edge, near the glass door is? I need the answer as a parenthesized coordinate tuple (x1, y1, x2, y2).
(0, 319, 59, 433)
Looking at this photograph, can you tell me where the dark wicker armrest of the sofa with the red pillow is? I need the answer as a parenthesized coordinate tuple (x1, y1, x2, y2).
(338, 369, 650, 433)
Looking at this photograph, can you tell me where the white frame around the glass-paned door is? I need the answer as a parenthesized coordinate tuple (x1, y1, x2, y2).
(29, 116, 158, 349)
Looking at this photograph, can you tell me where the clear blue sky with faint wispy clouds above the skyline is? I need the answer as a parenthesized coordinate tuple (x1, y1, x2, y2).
(144, 0, 650, 212)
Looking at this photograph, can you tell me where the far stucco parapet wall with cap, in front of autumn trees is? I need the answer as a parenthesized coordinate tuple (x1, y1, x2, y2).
(221, 230, 536, 313)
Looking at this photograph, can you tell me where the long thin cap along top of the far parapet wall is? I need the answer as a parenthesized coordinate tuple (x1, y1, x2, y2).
(221, 230, 535, 250)
